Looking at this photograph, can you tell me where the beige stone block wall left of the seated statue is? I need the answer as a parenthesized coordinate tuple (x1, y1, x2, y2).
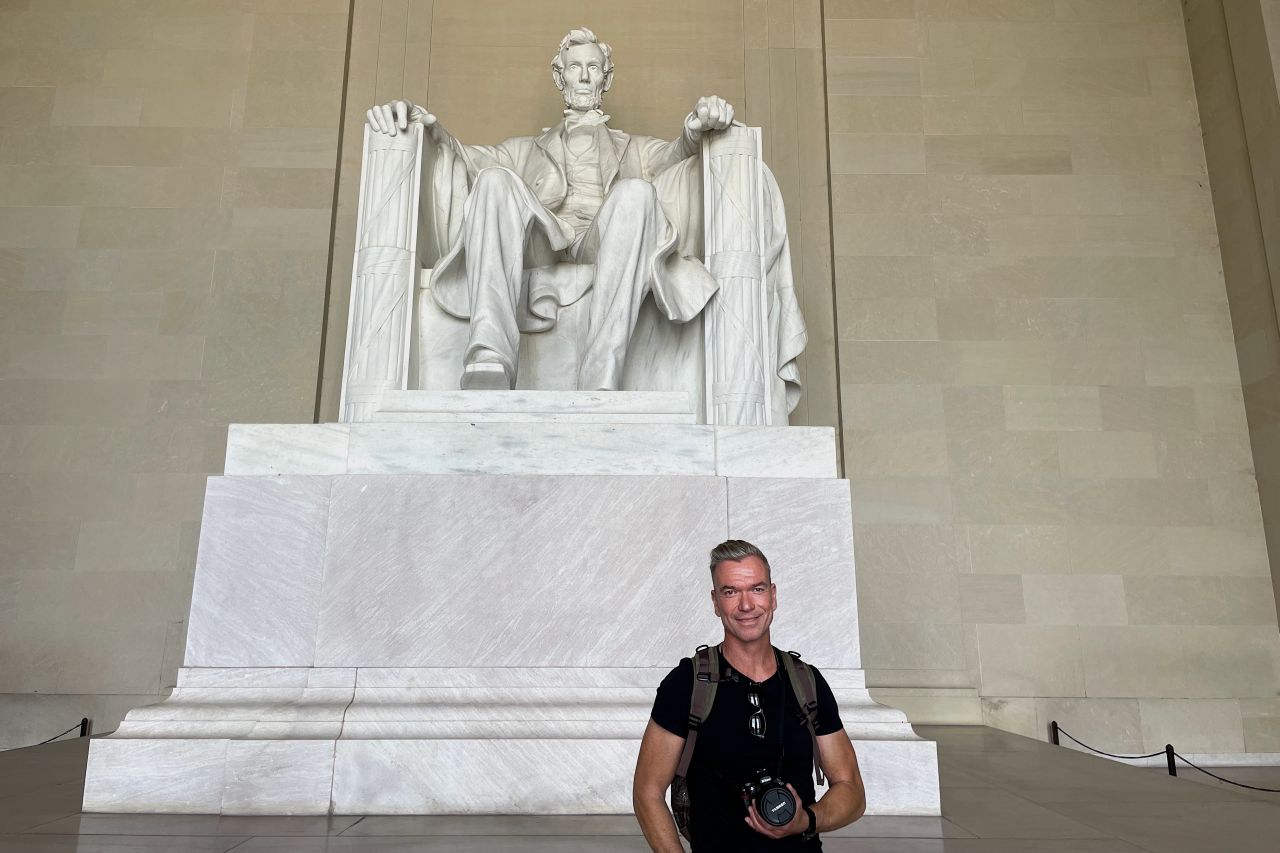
(0, 0, 348, 748)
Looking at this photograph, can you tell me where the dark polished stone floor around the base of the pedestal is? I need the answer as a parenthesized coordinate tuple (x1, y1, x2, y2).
(0, 726, 1280, 853)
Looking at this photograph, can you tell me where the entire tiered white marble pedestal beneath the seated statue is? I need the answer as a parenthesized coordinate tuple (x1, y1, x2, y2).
(84, 392, 938, 815)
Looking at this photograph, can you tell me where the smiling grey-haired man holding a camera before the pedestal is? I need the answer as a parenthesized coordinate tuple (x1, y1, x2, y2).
(632, 539, 867, 853)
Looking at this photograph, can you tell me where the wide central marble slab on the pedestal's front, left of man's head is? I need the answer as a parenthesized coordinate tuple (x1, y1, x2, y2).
(316, 471, 726, 667)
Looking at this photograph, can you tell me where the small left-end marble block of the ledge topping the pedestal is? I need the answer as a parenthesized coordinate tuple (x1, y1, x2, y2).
(223, 424, 351, 475)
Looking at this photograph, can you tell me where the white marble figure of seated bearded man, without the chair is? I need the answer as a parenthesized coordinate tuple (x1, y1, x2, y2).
(369, 28, 733, 391)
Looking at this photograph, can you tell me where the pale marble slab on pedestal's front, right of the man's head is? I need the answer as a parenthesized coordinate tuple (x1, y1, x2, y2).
(727, 478, 861, 669)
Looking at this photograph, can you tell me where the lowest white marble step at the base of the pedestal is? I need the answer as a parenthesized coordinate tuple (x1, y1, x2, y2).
(83, 736, 940, 815)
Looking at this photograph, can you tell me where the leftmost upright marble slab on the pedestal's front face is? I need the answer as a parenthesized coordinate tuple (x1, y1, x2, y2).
(186, 476, 332, 666)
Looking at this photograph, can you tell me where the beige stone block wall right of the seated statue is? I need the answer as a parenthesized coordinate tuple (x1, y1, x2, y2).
(824, 0, 1280, 752)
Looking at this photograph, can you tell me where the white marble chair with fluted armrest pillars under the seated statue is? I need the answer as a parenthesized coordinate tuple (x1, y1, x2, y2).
(340, 124, 787, 425)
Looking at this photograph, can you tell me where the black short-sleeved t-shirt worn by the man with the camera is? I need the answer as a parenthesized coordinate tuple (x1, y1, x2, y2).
(652, 652, 844, 853)
